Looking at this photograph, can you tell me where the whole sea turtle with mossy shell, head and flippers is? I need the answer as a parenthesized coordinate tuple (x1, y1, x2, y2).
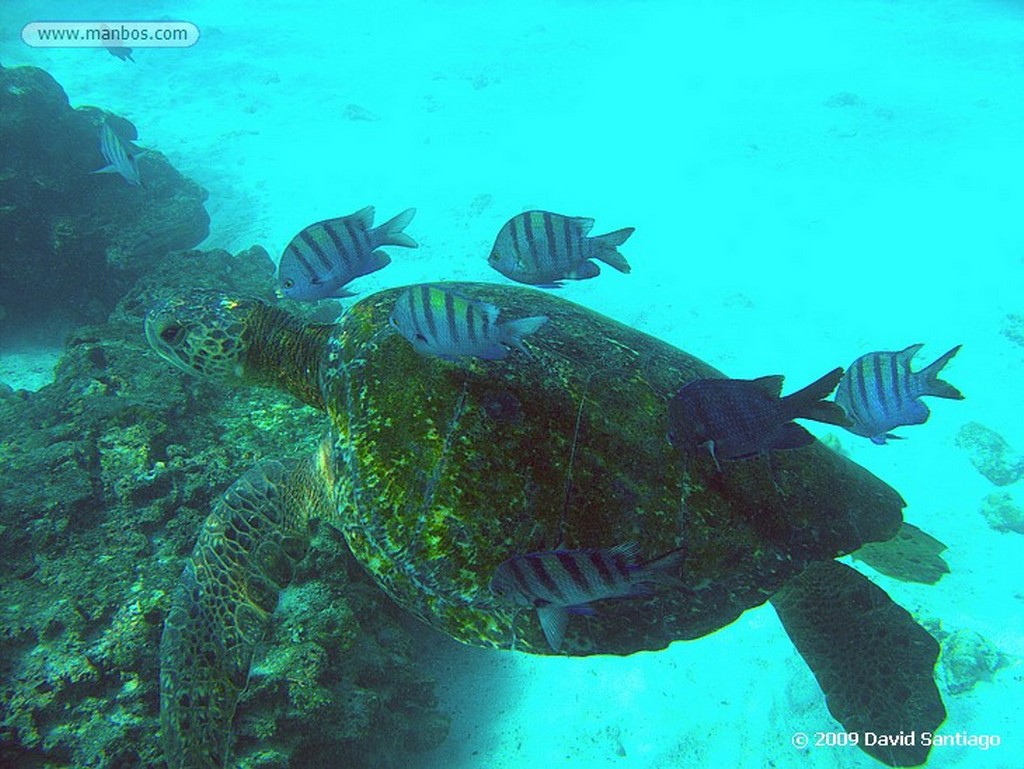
(146, 284, 945, 767)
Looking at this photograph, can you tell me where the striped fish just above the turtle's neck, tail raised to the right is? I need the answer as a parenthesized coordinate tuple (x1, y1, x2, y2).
(278, 206, 418, 301)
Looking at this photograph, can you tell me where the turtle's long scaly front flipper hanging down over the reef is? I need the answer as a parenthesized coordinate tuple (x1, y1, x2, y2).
(160, 462, 308, 769)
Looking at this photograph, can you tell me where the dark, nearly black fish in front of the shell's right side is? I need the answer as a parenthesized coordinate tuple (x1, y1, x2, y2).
(669, 369, 850, 465)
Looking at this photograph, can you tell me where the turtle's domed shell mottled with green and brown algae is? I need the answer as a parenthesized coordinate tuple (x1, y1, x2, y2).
(319, 284, 903, 654)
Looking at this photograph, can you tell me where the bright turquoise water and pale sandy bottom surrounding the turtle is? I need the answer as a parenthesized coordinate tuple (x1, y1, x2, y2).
(0, 0, 1024, 769)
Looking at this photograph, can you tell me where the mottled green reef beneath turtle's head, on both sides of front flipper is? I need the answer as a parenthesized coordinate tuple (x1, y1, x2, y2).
(0, 243, 447, 767)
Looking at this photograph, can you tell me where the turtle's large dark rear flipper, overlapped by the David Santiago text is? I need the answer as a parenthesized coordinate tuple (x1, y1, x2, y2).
(771, 561, 946, 766)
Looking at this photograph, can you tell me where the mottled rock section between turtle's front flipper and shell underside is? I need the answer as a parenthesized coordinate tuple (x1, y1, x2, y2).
(232, 527, 449, 768)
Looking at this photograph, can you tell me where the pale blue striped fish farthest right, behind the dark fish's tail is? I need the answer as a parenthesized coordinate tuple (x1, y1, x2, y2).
(836, 344, 964, 445)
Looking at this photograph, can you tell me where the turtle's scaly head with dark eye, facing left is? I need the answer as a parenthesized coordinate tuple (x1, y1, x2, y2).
(145, 290, 260, 382)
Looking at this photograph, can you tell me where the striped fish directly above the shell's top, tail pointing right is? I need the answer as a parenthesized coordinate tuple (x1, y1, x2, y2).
(487, 211, 634, 288)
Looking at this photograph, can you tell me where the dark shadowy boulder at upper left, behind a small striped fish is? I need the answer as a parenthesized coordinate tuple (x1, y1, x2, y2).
(0, 67, 210, 338)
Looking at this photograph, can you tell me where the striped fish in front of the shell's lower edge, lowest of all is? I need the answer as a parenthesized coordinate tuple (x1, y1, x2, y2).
(490, 542, 683, 651)
